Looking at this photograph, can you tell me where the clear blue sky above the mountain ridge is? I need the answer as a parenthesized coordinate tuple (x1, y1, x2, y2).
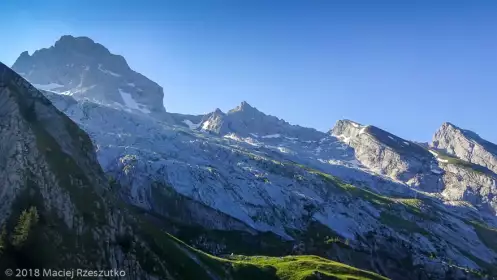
(0, 0, 497, 142)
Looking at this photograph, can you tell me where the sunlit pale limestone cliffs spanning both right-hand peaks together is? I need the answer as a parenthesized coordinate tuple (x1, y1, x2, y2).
(331, 120, 497, 213)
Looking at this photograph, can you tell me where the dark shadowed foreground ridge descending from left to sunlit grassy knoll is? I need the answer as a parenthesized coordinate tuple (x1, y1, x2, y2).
(0, 63, 385, 279)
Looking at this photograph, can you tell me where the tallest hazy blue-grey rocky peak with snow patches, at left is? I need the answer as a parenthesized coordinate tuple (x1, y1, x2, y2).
(12, 36, 165, 115)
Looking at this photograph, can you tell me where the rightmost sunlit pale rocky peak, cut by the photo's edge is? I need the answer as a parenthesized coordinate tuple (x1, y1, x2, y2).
(431, 123, 497, 173)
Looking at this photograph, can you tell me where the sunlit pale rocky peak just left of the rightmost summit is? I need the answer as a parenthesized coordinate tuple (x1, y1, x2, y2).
(330, 120, 442, 192)
